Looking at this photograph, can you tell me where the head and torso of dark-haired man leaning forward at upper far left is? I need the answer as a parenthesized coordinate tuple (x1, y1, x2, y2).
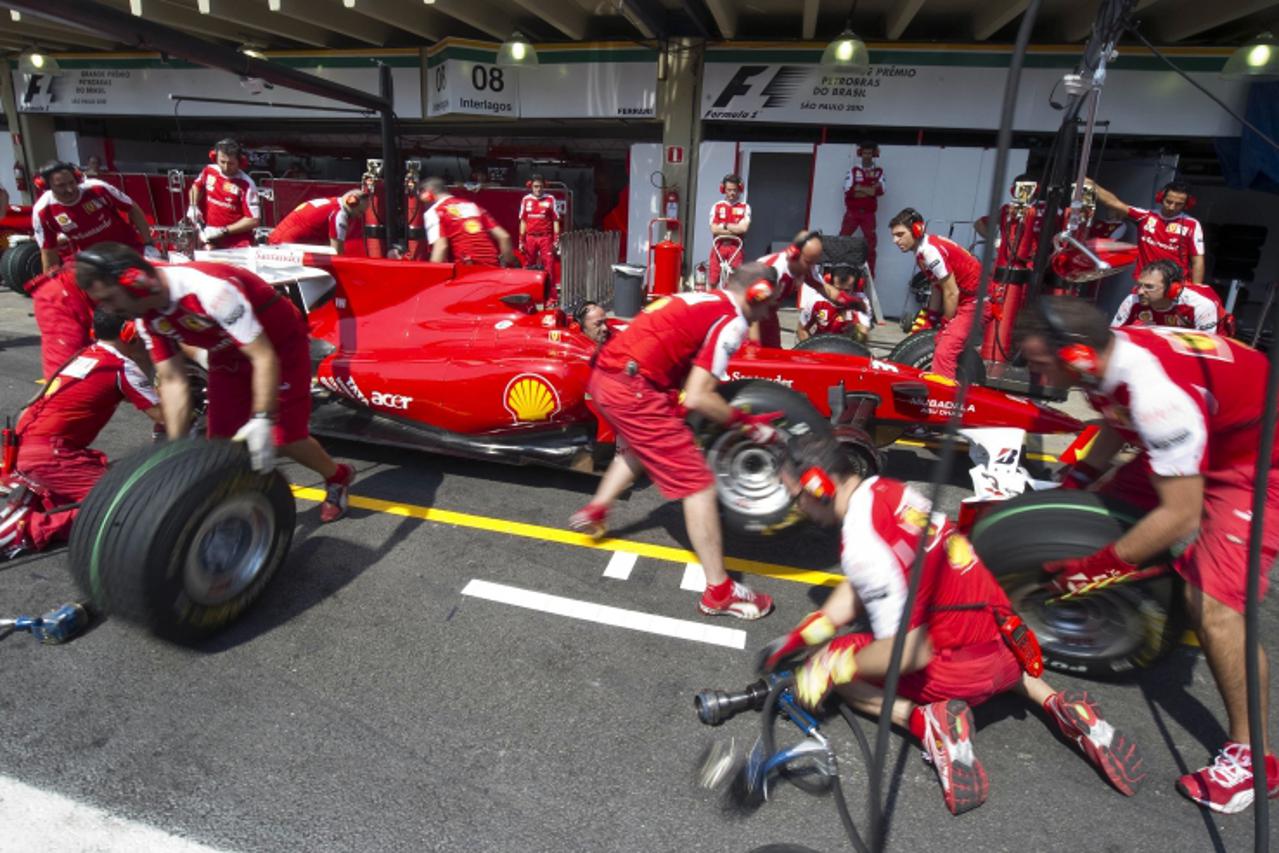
(31, 160, 160, 272)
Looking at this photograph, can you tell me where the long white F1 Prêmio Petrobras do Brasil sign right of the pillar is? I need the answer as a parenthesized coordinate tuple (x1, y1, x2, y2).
(701, 45, 1247, 137)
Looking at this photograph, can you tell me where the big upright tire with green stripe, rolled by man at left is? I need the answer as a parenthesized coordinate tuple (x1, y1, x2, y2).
(70, 440, 297, 645)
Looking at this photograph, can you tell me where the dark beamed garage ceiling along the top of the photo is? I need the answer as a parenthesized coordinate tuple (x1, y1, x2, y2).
(0, 0, 1279, 51)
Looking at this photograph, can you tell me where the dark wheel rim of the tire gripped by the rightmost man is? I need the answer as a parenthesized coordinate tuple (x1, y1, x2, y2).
(1008, 582, 1146, 660)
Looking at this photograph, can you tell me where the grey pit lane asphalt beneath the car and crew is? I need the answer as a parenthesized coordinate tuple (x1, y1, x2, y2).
(0, 293, 1279, 852)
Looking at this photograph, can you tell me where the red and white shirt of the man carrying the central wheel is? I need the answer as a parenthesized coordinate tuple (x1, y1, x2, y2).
(596, 290, 748, 391)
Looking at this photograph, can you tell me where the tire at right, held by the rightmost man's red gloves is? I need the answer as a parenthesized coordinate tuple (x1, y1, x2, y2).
(969, 489, 1181, 678)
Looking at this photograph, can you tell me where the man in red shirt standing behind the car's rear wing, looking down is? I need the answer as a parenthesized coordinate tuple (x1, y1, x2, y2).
(187, 139, 262, 249)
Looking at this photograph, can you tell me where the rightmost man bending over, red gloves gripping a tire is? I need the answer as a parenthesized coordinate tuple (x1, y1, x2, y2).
(1018, 297, 1279, 813)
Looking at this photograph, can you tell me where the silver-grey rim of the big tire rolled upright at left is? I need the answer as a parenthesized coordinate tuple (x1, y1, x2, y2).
(183, 492, 275, 606)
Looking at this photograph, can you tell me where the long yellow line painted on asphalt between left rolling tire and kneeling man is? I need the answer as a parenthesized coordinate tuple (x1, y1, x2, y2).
(292, 485, 844, 587)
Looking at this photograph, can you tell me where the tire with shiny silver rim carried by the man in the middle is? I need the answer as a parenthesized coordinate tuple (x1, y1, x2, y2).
(693, 380, 834, 536)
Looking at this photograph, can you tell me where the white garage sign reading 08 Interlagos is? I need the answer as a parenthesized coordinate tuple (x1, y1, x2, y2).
(422, 38, 657, 119)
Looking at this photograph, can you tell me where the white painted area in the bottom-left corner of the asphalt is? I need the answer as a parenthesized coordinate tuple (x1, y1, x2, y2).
(0, 776, 230, 853)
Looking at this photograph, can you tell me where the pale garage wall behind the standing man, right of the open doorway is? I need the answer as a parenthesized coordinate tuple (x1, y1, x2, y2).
(808, 145, 1028, 317)
